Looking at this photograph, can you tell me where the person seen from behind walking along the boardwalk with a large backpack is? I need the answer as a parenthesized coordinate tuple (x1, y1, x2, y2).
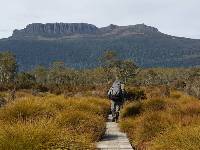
(108, 80, 125, 121)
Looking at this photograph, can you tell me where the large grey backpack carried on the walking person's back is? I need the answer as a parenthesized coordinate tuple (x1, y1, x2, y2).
(108, 81, 122, 101)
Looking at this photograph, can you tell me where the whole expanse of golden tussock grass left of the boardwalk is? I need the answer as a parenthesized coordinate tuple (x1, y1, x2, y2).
(0, 95, 110, 150)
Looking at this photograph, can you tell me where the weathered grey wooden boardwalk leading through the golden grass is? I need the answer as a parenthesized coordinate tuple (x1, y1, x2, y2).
(97, 115, 133, 150)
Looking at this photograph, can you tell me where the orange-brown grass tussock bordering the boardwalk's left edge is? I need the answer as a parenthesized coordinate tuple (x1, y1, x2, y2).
(56, 109, 106, 141)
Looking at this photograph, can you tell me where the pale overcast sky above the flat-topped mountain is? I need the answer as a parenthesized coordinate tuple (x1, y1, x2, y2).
(0, 0, 200, 39)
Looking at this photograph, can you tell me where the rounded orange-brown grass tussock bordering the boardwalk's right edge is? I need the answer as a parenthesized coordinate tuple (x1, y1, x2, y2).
(120, 112, 172, 148)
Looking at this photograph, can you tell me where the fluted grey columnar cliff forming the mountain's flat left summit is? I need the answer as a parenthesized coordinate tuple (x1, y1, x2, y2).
(12, 23, 98, 37)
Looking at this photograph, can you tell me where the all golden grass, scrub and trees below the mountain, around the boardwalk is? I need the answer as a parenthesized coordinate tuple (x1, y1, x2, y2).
(0, 51, 200, 150)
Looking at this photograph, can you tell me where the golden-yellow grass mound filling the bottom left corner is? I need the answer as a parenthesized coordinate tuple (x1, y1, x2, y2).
(0, 120, 94, 150)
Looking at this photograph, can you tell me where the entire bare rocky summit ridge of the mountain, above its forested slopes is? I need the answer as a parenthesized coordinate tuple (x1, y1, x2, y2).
(12, 23, 159, 38)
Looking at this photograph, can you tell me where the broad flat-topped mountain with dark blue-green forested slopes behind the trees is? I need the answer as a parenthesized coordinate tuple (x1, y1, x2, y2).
(0, 23, 200, 70)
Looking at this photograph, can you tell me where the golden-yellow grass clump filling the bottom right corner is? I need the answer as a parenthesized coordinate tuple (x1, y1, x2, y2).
(149, 126, 200, 150)
